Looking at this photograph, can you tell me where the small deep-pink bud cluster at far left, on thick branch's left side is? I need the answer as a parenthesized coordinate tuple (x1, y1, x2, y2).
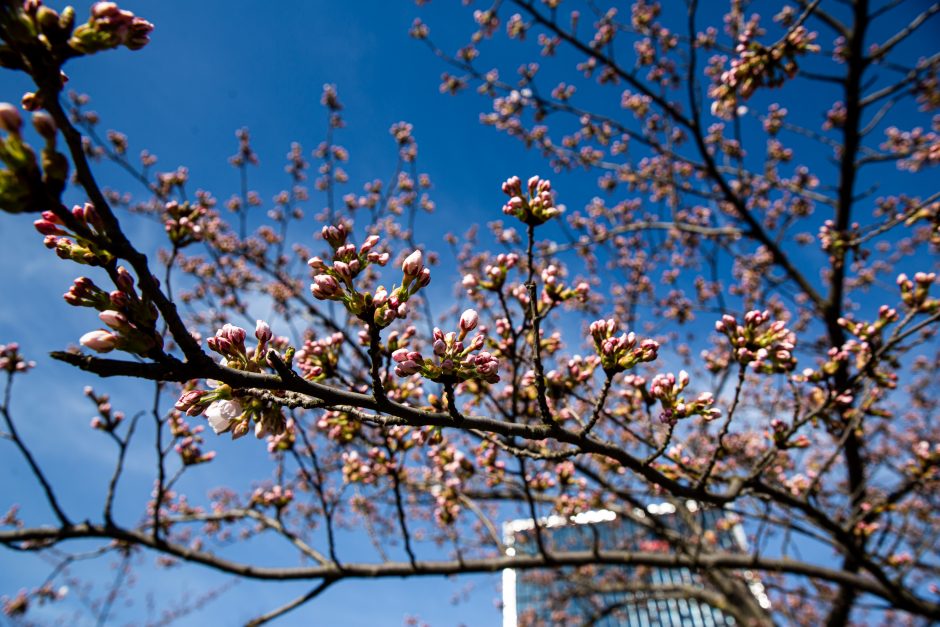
(33, 203, 114, 266)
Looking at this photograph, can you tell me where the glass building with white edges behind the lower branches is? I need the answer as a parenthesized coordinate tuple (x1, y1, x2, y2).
(503, 502, 770, 627)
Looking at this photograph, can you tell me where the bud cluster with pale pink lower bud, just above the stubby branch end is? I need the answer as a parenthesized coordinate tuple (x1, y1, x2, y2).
(70, 266, 163, 356)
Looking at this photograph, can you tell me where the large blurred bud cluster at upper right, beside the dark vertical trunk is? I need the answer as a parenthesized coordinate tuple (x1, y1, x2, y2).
(709, 22, 819, 118)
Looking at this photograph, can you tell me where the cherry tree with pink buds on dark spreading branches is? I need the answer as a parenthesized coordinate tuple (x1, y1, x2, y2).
(0, 0, 940, 625)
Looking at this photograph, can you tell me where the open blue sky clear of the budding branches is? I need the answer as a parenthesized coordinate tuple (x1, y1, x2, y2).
(0, 0, 930, 626)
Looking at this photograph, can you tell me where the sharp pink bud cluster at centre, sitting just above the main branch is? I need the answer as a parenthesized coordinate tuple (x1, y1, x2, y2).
(392, 309, 499, 383)
